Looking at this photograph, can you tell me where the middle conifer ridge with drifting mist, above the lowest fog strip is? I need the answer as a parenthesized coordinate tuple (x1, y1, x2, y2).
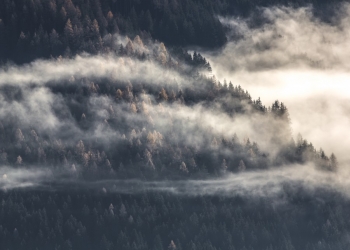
(0, 36, 336, 178)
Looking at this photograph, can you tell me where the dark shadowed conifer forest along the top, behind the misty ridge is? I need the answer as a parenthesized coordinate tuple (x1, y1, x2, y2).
(0, 0, 346, 63)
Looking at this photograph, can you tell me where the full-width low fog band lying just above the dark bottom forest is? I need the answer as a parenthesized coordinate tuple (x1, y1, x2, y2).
(0, 163, 350, 204)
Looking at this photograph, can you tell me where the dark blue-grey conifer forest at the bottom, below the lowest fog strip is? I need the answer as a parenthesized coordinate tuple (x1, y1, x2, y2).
(0, 187, 350, 250)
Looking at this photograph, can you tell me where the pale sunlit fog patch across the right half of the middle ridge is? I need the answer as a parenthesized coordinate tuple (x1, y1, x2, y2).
(143, 99, 290, 157)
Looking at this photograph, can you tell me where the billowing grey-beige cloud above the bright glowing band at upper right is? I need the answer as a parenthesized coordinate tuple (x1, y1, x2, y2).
(213, 4, 350, 72)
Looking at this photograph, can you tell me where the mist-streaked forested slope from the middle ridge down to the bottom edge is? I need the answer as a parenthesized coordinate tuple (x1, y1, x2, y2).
(0, 33, 340, 250)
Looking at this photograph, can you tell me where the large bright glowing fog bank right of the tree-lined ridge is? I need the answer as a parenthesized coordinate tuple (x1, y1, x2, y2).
(201, 4, 350, 163)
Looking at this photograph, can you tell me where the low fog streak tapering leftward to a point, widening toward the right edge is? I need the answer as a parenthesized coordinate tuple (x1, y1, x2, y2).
(78, 163, 350, 199)
